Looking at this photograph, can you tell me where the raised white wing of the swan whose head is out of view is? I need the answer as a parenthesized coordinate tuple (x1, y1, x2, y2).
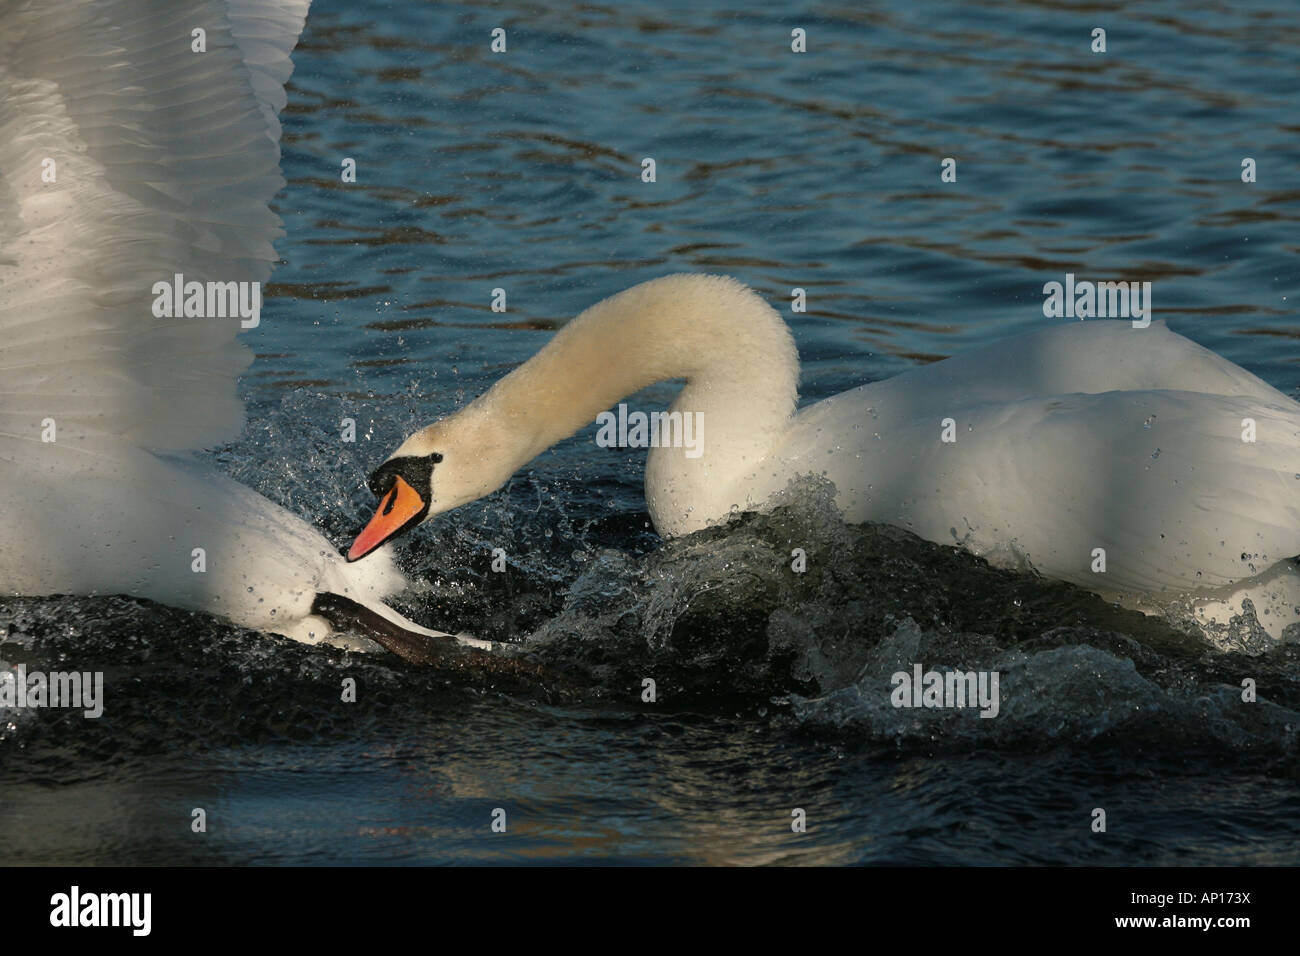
(0, 0, 308, 462)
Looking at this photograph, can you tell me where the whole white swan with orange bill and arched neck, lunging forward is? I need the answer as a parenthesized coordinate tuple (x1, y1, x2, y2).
(348, 276, 1300, 635)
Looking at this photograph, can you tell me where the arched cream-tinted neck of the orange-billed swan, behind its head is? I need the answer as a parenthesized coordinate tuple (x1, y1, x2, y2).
(459, 276, 798, 473)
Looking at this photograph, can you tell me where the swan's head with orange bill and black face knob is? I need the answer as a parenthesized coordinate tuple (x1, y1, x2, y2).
(347, 408, 515, 561)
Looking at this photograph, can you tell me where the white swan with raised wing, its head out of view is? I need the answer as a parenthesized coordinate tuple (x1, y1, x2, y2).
(0, 0, 478, 650)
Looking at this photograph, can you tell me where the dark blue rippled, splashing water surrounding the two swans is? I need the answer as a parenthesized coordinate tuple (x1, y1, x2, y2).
(0, 0, 1300, 864)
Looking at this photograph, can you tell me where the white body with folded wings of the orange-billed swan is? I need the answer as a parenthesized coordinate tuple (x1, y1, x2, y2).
(777, 321, 1300, 598)
